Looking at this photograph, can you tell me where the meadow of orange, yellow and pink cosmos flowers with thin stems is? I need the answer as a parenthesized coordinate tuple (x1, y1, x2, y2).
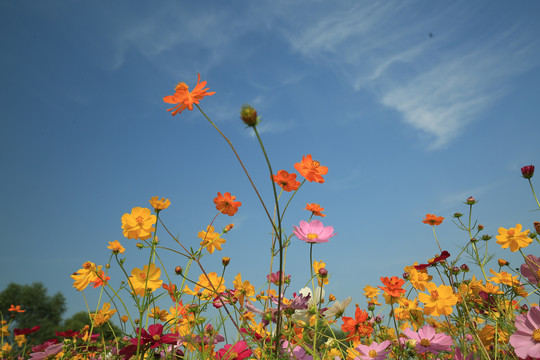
(0, 75, 540, 360)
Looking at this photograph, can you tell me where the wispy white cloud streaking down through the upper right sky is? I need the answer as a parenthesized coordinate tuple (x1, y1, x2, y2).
(276, 2, 539, 149)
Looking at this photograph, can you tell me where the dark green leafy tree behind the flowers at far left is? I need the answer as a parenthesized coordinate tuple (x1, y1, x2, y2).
(0, 282, 66, 344)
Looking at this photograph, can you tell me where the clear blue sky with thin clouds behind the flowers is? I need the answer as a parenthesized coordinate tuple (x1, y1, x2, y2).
(0, 0, 540, 320)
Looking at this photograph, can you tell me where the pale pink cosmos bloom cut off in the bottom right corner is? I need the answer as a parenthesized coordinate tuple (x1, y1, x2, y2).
(510, 306, 540, 359)
